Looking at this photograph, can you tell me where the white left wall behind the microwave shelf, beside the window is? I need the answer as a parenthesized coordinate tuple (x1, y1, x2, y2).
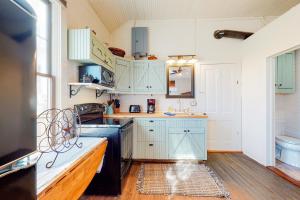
(61, 0, 110, 107)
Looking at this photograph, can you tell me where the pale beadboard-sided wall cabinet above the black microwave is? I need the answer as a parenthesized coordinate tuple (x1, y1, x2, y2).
(68, 28, 115, 71)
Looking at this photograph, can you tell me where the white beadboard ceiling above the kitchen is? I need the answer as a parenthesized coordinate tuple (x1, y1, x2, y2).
(88, 0, 300, 31)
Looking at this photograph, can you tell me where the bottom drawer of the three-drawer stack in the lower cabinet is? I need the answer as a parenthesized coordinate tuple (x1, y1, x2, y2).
(137, 142, 167, 159)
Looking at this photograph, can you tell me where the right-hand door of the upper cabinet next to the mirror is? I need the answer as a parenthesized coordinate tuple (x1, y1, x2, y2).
(148, 61, 166, 94)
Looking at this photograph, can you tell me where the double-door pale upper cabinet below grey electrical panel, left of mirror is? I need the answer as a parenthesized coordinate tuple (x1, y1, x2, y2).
(132, 60, 166, 94)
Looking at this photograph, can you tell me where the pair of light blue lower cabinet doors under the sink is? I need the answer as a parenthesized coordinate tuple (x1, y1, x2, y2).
(168, 132, 205, 160)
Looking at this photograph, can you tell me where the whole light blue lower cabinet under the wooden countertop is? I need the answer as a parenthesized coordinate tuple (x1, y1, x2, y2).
(133, 118, 207, 160)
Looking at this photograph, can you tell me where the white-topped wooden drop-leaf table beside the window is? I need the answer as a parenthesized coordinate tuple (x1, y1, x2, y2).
(37, 137, 107, 200)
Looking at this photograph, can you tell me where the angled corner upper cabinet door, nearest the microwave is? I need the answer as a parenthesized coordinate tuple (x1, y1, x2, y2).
(115, 58, 132, 92)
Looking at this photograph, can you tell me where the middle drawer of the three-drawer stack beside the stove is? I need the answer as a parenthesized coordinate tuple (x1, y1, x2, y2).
(137, 126, 165, 142)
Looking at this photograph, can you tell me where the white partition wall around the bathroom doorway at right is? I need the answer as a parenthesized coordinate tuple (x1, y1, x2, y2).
(242, 4, 300, 165)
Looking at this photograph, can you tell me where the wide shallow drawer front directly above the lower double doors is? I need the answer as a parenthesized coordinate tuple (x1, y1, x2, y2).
(168, 119, 205, 128)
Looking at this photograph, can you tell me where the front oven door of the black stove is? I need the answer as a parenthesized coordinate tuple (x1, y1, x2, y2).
(120, 121, 133, 178)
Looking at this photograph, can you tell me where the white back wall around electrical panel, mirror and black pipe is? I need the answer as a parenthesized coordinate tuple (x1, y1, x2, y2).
(111, 17, 275, 112)
